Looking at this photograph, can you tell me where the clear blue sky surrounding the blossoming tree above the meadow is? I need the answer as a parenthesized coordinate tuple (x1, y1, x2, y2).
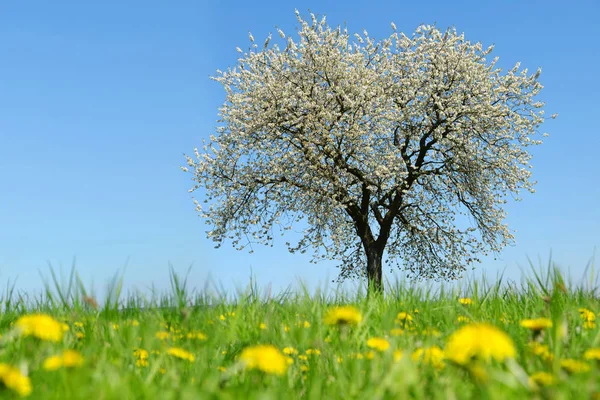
(0, 0, 600, 300)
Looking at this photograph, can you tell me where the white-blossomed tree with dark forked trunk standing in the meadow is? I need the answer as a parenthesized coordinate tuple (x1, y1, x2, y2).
(182, 11, 545, 289)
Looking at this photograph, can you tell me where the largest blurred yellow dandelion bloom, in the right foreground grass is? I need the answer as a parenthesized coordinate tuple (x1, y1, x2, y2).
(444, 323, 516, 364)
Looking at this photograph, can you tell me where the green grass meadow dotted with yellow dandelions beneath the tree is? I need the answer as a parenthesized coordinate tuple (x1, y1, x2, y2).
(0, 263, 600, 400)
